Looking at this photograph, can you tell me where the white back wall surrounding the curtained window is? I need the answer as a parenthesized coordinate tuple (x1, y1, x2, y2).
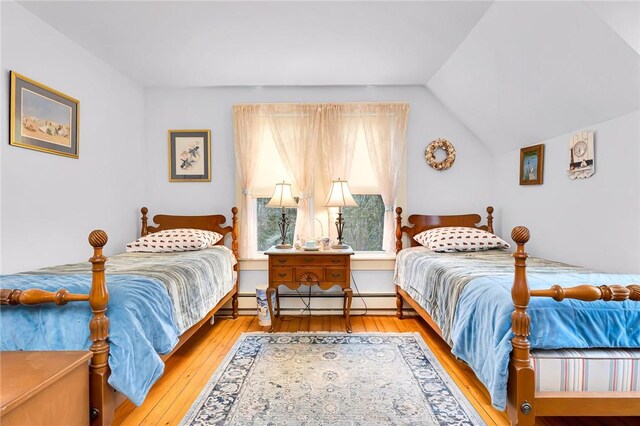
(145, 86, 492, 300)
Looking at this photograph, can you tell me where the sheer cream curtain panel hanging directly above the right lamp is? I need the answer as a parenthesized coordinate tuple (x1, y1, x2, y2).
(322, 104, 361, 238)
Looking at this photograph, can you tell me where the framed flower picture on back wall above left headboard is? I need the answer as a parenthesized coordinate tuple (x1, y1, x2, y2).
(169, 130, 211, 182)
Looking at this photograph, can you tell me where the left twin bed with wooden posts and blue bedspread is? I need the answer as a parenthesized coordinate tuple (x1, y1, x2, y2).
(0, 208, 238, 424)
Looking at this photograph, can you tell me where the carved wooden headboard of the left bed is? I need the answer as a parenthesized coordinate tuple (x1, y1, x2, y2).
(140, 207, 238, 253)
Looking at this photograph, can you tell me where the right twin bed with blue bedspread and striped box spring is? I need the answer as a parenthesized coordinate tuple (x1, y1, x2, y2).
(394, 208, 640, 424)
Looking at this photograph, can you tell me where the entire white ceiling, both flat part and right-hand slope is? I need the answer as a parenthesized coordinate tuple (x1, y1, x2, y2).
(15, 1, 640, 152)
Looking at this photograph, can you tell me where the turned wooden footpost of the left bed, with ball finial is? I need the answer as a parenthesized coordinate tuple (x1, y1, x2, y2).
(89, 230, 113, 425)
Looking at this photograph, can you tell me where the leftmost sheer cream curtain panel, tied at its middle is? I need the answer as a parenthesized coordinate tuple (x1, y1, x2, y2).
(233, 105, 265, 257)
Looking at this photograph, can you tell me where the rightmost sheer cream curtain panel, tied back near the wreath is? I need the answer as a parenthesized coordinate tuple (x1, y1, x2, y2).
(362, 104, 409, 253)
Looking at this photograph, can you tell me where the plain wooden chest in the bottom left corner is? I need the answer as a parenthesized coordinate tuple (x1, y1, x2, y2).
(0, 351, 91, 426)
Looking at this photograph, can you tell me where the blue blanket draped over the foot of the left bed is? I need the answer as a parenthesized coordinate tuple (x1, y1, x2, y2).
(0, 274, 178, 405)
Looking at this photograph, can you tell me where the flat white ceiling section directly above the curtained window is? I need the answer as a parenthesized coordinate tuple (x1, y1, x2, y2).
(19, 1, 491, 87)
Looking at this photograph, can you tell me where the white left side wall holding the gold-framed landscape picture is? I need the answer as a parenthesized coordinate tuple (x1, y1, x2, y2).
(0, 2, 146, 273)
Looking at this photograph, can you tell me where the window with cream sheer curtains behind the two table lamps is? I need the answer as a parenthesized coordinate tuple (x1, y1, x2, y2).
(234, 104, 408, 257)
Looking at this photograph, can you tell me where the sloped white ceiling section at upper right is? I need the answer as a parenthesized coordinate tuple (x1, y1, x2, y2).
(427, 2, 640, 152)
